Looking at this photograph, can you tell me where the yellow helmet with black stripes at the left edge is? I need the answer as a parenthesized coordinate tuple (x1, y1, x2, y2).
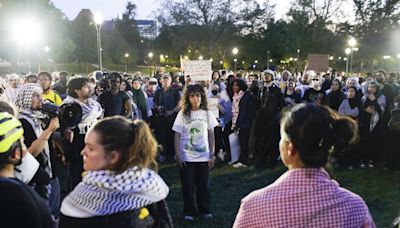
(0, 112, 24, 155)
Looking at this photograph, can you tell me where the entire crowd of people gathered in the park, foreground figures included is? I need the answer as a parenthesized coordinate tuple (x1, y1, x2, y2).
(0, 66, 400, 227)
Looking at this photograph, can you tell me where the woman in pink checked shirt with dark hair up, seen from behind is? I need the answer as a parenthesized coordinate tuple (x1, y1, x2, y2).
(233, 104, 375, 228)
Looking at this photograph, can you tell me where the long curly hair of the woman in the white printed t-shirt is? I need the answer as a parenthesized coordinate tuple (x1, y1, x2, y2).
(180, 84, 208, 117)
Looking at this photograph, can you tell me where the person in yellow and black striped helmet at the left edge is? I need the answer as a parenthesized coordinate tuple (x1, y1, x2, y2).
(0, 112, 52, 228)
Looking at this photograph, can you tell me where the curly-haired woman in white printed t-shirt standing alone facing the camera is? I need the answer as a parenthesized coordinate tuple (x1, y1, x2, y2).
(172, 84, 218, 221)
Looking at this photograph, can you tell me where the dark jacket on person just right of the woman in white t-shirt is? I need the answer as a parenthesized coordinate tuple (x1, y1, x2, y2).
(236, 91, 255, 128)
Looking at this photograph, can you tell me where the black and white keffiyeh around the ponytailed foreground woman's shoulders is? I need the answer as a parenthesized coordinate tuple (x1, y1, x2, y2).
(61, 167, 169, 218)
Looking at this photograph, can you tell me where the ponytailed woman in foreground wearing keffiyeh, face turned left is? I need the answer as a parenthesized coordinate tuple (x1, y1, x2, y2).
(60, 116, 171, 228)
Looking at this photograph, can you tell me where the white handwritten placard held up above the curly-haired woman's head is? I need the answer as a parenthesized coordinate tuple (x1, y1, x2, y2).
(182, 60, 212, 81)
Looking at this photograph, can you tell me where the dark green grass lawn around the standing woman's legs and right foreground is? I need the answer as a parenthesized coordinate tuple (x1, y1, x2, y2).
(159, 164, 400, 227)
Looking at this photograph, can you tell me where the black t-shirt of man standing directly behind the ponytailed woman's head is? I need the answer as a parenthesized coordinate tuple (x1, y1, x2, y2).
(99, 91, 129, 117)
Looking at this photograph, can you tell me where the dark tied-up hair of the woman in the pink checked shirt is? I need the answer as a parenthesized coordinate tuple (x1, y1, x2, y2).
(281, 103, 358, 168)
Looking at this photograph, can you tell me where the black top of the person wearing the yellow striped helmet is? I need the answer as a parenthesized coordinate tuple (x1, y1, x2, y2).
(0, 177, 52, 228)
